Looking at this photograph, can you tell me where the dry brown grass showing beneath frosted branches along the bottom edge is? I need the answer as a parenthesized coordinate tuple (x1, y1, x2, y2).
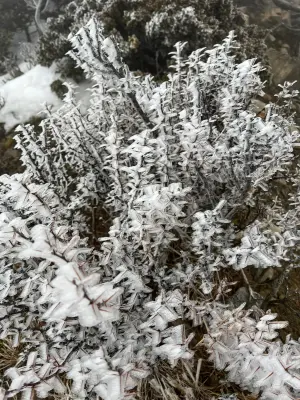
(0, 332, 257, 400)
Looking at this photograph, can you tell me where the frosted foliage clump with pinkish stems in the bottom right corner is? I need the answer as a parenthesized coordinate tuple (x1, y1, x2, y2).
(204, 307, 300, 400)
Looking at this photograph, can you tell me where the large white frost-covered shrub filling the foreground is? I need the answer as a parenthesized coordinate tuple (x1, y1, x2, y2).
(0, 19, 299, 400)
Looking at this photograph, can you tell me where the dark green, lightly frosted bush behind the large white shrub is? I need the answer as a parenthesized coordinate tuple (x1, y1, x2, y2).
(39, 0, 268, 77)
